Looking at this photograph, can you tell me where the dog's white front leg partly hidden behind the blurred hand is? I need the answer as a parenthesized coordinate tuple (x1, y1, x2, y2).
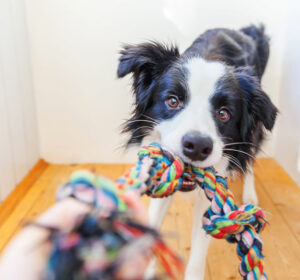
(145, 195, 174, 279)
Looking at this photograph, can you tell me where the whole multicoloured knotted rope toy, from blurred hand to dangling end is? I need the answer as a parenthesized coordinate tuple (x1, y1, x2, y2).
(45, 143, 267, 280)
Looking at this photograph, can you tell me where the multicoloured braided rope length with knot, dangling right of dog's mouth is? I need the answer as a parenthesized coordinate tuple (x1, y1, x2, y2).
(201, 168, 267, 279)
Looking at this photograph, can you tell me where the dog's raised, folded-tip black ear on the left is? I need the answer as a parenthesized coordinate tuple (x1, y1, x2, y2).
(117, 42, 179, 109)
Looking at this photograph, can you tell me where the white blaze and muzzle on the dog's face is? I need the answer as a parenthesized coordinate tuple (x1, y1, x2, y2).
(154, 57, 225, 167)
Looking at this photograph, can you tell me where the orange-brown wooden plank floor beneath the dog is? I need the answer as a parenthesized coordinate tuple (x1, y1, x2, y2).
(0, 159, 300, 280)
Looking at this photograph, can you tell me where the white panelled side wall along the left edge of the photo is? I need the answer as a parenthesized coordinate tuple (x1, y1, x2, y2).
(0, 0, 39, 201)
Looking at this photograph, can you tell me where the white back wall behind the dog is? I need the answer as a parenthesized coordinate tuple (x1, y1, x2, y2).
(25, 0, 286, 163)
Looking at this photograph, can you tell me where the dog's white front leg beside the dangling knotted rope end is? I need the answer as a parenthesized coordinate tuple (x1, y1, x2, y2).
(185, 190, 210, 280)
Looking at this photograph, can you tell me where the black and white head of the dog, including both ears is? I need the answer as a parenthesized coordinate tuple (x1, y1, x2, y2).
(118, 42, 277, 171)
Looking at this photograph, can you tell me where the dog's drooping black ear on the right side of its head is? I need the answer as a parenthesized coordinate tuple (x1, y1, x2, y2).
(235, 67, 278, 138)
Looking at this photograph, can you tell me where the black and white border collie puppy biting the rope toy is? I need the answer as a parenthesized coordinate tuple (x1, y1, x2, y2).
(118, 25, 277, 280)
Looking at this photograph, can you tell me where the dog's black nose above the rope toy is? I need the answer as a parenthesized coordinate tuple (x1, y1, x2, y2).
(182, 131, 213, 161)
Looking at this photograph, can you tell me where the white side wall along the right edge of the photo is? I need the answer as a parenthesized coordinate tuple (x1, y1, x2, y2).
(275, 0, 300, 184)
